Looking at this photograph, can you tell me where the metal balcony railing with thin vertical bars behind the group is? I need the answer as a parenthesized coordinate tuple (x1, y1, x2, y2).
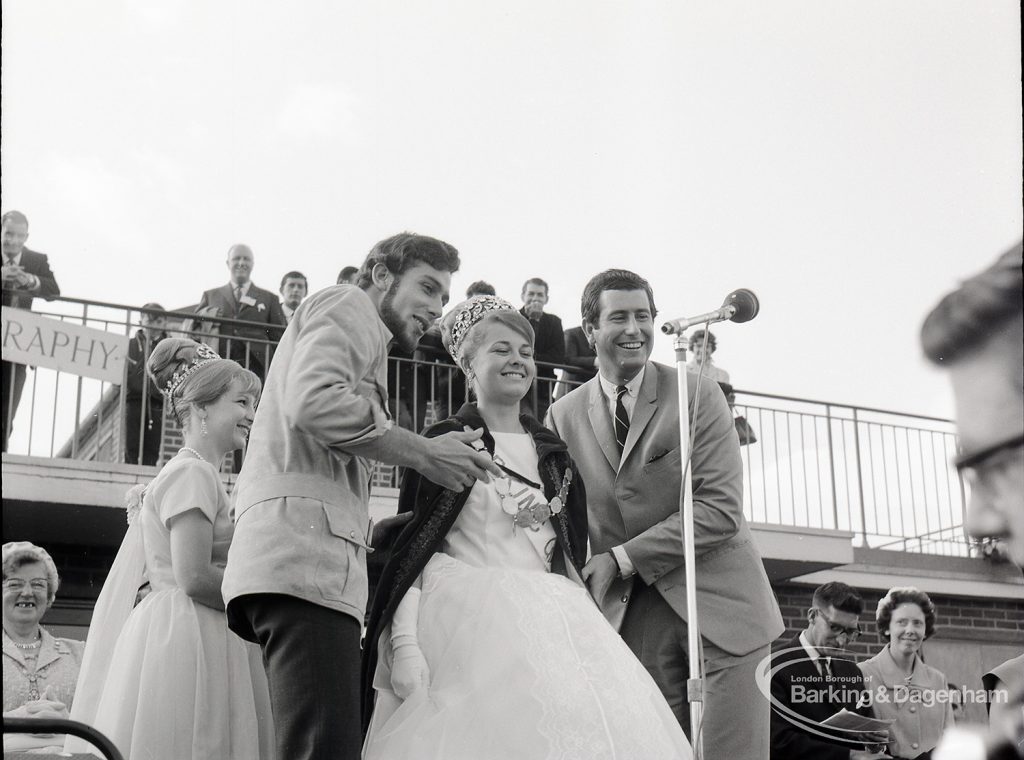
(4, 298, 977, 556)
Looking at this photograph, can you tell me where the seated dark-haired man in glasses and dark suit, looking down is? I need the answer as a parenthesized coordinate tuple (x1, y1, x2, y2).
(771, 583, 888, 760)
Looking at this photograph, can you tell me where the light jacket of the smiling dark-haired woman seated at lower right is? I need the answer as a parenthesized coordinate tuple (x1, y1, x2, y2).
(857, 645, 953, 757)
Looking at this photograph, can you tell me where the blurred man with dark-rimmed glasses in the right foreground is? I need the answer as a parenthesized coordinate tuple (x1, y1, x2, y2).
(921, 242, 1024, 760)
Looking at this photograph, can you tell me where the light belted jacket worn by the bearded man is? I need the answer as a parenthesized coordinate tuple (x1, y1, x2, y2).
(223, 285, 391, 635)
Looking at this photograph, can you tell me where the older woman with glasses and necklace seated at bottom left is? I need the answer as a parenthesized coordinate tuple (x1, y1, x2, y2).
(3, 541, 85, 749)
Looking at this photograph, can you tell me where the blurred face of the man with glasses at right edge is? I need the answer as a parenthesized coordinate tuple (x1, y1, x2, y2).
(949, 323, 1024, 566)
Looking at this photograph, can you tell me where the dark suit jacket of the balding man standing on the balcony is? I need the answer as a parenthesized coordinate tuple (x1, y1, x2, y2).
(197, 283, 288, 378)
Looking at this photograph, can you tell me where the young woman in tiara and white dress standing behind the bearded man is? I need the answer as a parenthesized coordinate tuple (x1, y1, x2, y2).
(67, 338, 273, 760)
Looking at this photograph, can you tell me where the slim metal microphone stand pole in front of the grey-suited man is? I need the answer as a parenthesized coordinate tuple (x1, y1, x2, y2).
(673, 331, 703, 760)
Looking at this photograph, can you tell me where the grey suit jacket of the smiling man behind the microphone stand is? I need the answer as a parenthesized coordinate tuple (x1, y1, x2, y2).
(548, 362, 783, 656)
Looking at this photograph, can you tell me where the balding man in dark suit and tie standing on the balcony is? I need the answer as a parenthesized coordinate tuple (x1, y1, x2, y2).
(197, 243, 288, 380)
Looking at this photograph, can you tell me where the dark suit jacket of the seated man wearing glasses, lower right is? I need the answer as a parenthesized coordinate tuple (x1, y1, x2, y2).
(771, 636, 872, 760)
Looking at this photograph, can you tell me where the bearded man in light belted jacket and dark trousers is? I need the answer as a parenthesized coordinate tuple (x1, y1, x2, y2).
(223, 233, 501, 760)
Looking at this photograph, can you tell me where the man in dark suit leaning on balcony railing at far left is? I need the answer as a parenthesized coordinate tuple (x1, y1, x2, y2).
(0, 211, 60, 451)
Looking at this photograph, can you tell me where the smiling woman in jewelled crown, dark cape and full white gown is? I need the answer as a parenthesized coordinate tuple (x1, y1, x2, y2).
(364, 296, 690, 760)
